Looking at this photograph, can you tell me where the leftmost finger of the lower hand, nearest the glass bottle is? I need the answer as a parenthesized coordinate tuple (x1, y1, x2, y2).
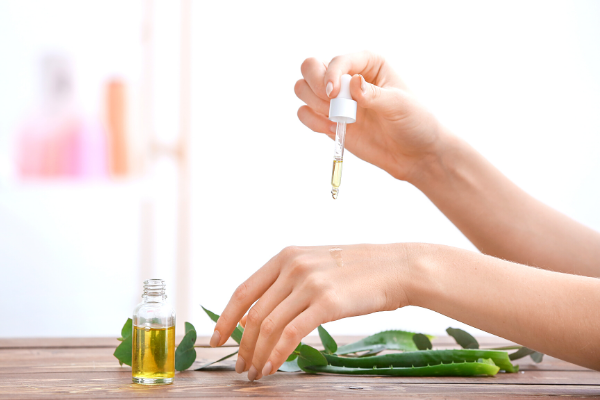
(210, 253, 281, 347)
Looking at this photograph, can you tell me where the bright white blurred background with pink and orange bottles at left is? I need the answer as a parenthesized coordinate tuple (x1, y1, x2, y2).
(0, 0, 600, 337)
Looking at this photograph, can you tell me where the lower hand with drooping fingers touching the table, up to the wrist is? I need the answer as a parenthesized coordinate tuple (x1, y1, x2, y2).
(210, 244, 410, 381)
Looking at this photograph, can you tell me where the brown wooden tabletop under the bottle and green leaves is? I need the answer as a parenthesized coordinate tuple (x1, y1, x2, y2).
(0, 337, 600, 400)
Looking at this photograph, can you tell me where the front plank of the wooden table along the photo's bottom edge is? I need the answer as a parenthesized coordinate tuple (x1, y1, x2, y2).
(0, 371, 600, 399)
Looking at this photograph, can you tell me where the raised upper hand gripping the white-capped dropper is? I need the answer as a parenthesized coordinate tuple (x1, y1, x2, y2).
(294, 52, 447, 182)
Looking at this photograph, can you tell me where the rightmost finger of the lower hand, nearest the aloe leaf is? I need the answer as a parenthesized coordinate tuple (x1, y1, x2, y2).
(257, 307, 324, 376)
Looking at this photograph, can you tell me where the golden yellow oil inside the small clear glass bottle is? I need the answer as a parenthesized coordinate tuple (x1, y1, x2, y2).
(131, 326, 175, 385)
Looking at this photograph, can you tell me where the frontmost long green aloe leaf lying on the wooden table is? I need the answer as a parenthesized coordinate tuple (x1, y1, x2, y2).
(304, 362, 500, 376)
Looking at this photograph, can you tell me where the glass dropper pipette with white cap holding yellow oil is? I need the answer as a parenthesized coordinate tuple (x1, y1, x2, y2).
(329, 74, 356, 199)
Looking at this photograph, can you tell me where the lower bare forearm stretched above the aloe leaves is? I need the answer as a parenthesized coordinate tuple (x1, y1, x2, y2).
(399, 244, 600, 370)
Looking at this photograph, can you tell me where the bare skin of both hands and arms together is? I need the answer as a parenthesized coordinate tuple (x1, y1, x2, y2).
(211, 52, 600, 380)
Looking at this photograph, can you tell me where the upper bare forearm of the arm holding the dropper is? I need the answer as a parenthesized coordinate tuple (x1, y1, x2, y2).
(411, 134, 600, 276)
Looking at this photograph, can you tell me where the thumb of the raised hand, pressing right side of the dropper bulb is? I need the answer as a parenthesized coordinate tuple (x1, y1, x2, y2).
(350, 74, 404, 113)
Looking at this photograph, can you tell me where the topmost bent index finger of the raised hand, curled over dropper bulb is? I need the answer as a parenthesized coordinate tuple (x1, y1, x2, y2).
(323, 51, 384, 98)
